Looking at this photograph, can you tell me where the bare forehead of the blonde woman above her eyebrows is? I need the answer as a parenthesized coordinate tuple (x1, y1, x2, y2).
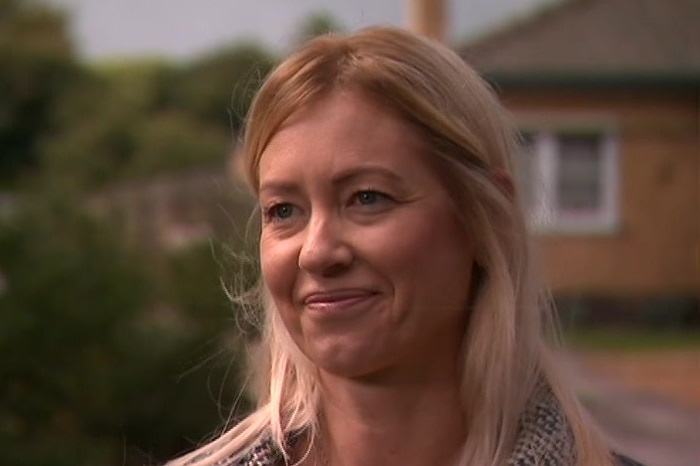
(259, 92, 426, 186)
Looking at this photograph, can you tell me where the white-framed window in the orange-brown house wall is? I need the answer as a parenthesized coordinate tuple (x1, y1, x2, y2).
(518, 130, 618, 233)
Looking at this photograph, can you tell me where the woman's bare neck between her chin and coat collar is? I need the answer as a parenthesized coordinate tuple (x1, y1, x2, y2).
(310, 356, 466, 466)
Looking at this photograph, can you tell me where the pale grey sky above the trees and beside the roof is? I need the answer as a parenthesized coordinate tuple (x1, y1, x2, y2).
(49, 0, 552, 60)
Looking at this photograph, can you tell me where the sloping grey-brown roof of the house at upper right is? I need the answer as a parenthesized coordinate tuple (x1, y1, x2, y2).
(459, 0, 700, 88)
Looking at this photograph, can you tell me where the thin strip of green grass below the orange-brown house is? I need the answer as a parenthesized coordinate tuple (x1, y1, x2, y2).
(563, 329, 700, 351)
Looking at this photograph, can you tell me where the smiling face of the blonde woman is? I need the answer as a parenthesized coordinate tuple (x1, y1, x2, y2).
(259, 93, 474, 377)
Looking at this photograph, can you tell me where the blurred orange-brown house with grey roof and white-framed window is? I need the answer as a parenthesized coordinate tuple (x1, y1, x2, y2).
(459, 0, 700, 322)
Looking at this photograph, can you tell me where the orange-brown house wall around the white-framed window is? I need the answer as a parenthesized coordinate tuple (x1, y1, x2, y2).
(501, 90, 700, 296)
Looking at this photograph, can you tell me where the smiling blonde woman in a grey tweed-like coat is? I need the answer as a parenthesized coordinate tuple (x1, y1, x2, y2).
(174, 28, 644, 466)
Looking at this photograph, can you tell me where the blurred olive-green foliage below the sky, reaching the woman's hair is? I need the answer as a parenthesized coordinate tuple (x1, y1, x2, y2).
(36, 45, 274, 188)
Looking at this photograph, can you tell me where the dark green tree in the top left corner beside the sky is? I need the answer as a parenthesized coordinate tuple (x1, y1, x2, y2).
(0, 0, 79, 185)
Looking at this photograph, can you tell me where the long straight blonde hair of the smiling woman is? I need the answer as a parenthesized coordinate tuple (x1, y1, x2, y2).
(170, 28, 611, 466)
